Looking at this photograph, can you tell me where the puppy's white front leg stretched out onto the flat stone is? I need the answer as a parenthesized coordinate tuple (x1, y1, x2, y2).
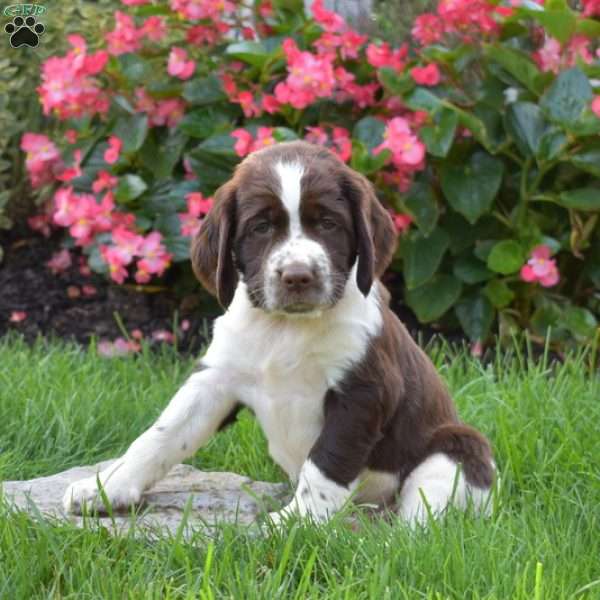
(63, 367, 236, 512)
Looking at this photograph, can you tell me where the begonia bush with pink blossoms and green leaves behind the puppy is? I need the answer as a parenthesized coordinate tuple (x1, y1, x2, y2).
(22, 0, 600, 347)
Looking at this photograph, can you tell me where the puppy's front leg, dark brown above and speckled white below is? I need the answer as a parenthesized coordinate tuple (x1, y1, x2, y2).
(269, 383, 382, 523)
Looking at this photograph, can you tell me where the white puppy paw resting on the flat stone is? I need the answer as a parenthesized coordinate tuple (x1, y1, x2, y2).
(63, 473, 142, 514)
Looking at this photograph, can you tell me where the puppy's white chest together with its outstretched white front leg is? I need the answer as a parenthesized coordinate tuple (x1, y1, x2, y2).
(64, 271, 382, 511)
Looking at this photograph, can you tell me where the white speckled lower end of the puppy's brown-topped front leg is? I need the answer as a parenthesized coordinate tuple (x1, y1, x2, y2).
(269, 459, 356, 524)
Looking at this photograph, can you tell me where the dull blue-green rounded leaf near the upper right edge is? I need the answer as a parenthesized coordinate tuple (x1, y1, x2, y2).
(540, 67, 594, 129)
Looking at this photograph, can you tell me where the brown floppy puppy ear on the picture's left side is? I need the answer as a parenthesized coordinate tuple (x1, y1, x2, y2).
(190, 181, 238, 308)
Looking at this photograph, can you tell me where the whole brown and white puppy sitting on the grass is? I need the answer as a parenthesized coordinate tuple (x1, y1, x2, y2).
(64, 142, 494, 522)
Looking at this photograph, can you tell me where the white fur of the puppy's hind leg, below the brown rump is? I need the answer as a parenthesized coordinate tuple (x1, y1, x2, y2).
(400, 452, 490, 525)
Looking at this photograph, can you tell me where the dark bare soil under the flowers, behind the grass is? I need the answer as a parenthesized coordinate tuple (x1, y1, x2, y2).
(0, 229, 460, 354)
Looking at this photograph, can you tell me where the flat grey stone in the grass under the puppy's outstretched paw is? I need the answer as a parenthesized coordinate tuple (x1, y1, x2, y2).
(2, 460, 289, 537)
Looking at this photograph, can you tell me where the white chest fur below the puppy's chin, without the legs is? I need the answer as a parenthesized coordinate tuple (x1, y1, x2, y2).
(203, 272, 381, 480)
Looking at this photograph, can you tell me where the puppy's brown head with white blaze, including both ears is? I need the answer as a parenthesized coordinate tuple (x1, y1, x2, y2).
(191, 142, 396, 314)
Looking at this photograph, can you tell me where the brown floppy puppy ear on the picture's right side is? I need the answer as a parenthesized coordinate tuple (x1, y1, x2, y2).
(344, 170, 397, 296)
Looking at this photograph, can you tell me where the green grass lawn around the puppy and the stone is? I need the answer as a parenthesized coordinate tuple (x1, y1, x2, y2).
(0, 339, 600, 600)
